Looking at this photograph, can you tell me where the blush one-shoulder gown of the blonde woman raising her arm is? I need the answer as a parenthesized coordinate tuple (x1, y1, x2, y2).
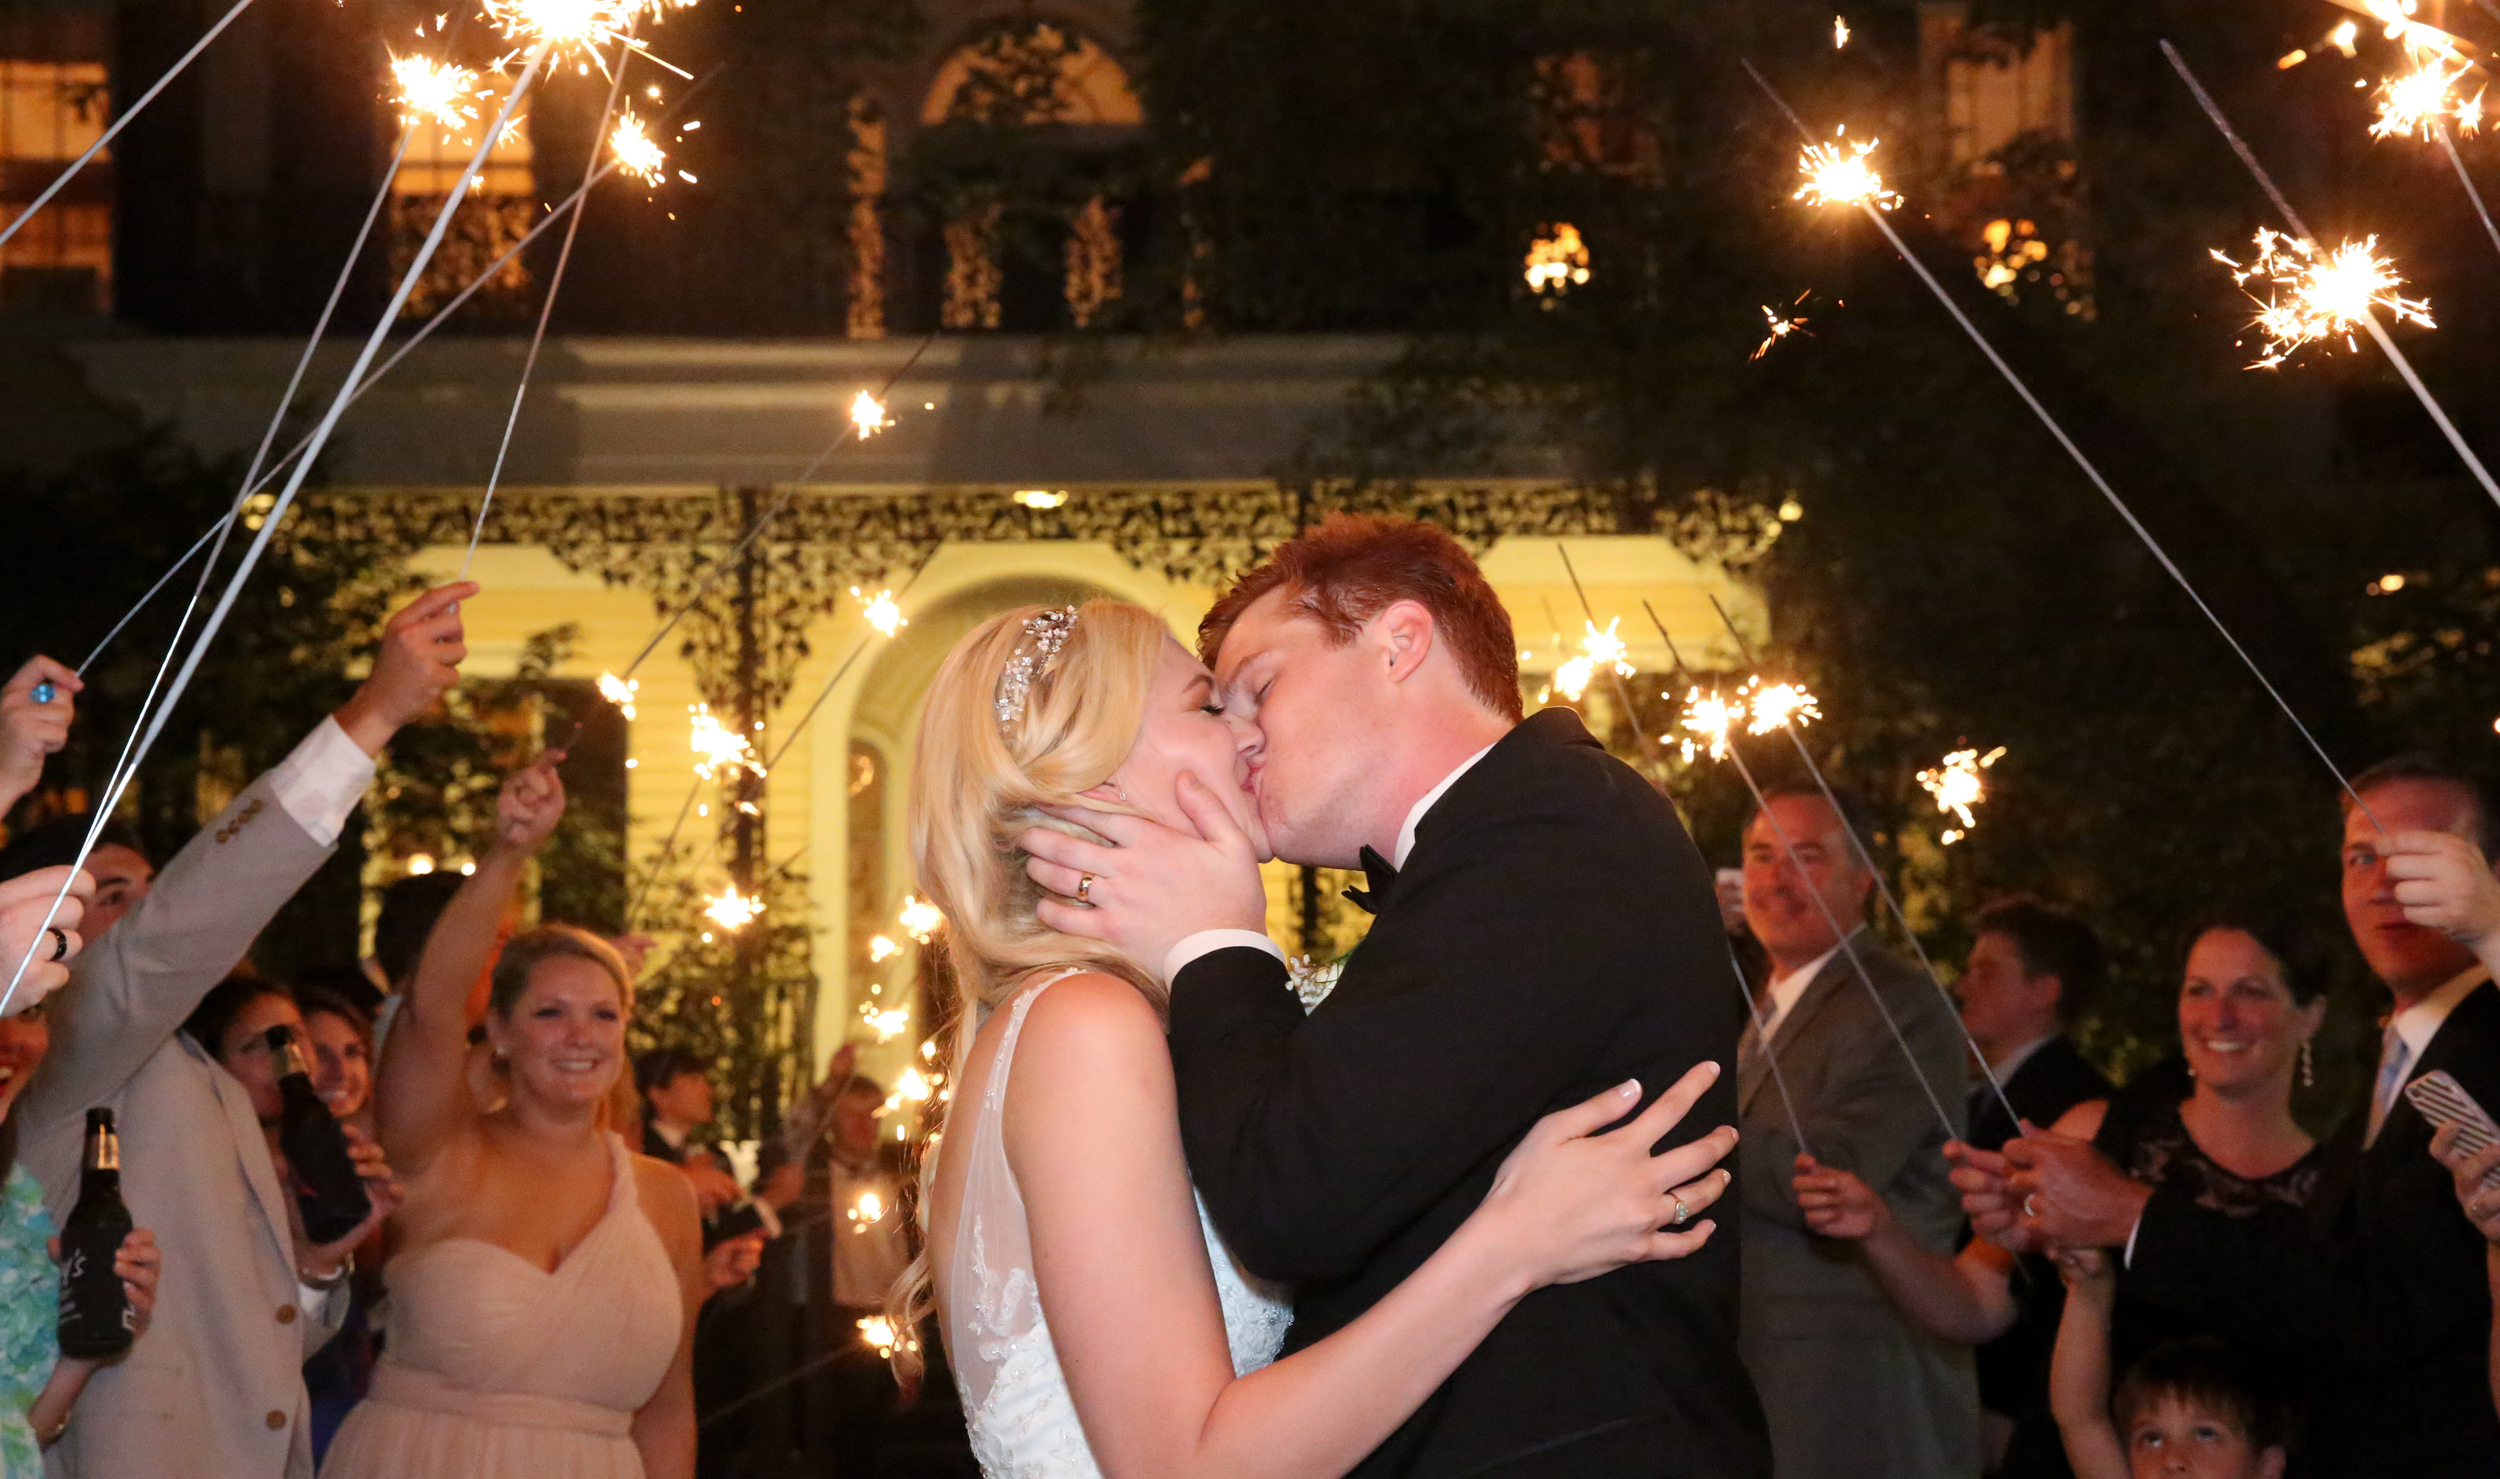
(323, 1134, 685, 1479)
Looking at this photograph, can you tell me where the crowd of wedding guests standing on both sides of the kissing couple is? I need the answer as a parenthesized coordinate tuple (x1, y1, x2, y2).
(0, 567, 2500, 1479)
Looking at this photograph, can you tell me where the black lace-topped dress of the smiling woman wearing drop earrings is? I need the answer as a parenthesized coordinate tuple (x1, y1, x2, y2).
(2000, 1064, 2325, 1479)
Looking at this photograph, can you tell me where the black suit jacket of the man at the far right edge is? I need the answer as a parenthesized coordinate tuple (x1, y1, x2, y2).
(2125, 982, 2500, 1479)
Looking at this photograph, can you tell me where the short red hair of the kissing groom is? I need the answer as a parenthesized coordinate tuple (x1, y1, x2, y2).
(1198, 515, 1520, 720)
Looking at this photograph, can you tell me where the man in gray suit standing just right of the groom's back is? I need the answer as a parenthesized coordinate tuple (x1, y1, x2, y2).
(1738, 792, 1980, 1479)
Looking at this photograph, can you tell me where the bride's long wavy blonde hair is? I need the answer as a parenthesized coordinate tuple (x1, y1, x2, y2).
(885, 600, 1173, 1382)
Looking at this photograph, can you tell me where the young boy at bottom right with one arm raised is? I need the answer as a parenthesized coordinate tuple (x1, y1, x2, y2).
(2048, 1249, 2288, 1479)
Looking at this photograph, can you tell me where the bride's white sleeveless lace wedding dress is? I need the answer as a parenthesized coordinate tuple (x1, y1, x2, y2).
(945, 972, 1293, 1479)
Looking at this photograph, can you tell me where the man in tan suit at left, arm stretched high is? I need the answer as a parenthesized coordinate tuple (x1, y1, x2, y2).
(18, 582, 478, 1479)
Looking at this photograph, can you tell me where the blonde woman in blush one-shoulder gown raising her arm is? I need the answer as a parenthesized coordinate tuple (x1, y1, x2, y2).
(323, 752, 705, 1479)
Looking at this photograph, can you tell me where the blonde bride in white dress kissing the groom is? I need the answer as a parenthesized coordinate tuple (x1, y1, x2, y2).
(895, 600, 1735, 1479)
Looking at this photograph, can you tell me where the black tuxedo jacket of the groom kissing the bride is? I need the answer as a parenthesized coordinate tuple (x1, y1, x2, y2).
(1173, 710, 1770, 1479)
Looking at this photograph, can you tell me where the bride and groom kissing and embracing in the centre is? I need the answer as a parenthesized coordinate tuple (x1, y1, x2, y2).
(895, 515, 1770, 1479)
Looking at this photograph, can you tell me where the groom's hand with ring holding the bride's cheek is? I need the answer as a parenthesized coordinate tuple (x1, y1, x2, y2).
(1015, 774, 1268, 974)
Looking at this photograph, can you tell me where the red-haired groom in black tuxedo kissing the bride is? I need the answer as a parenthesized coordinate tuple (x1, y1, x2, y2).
(1025, 515, 1770, 1479)
